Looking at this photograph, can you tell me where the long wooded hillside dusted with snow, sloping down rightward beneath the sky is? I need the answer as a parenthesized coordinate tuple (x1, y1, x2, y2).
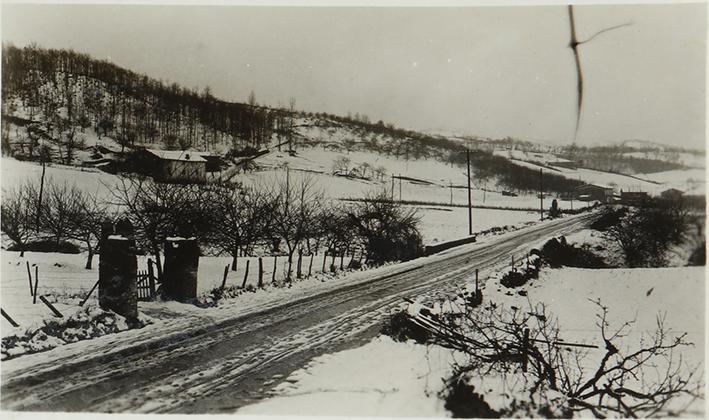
(2, 45, 682, 192)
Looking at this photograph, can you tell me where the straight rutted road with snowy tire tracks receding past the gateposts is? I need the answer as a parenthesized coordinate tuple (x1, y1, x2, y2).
(2, 214, 595, 413)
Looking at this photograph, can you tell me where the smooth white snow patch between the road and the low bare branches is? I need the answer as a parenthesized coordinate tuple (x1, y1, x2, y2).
(237, 336, 454, 417)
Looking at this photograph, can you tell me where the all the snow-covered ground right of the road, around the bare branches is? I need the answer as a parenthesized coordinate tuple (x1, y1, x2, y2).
(238, 267, 705, 416)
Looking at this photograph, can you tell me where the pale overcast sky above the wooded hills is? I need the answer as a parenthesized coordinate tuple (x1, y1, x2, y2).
(2, 4, 707, 148)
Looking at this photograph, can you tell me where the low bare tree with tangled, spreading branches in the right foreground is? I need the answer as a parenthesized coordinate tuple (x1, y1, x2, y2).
(412, 301, 703, 418)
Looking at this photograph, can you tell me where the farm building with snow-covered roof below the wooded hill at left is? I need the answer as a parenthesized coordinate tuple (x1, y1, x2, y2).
(145, 149, 207, 183)
